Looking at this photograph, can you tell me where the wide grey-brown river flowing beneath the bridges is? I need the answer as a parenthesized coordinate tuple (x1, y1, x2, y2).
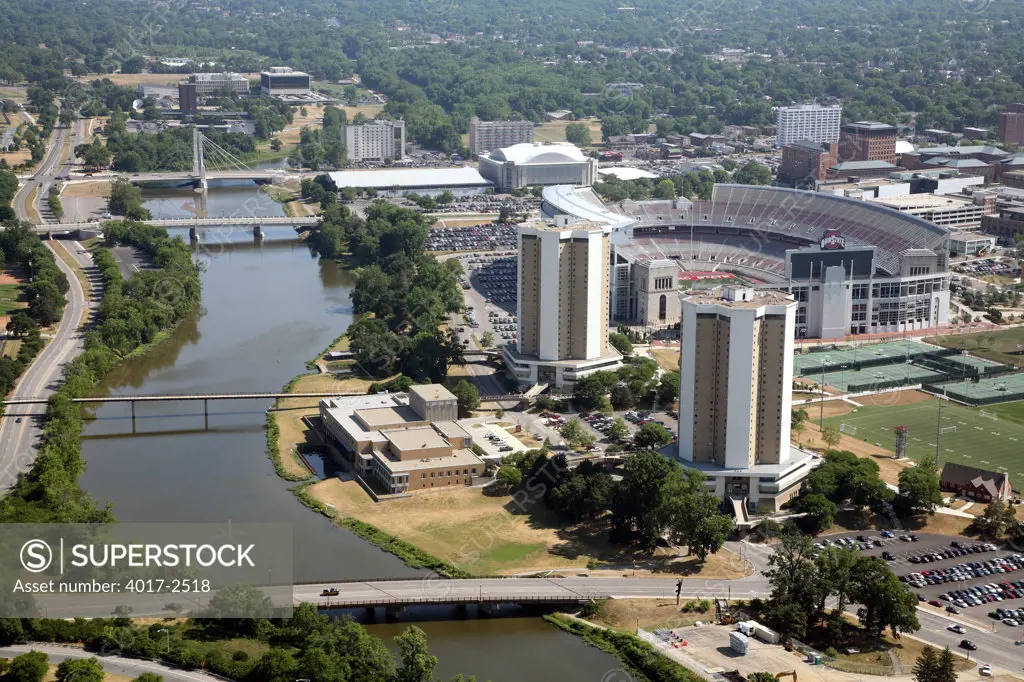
(75, 185, 618, 682)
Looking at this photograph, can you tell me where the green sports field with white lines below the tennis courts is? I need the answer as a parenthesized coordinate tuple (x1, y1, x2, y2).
(825, 400, 1024, 486)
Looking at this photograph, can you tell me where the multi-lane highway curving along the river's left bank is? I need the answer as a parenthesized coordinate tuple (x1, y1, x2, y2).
(0, 114, 91, 492)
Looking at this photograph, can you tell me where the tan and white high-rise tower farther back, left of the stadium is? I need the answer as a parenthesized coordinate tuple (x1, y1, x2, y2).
(505, 215, 622, 388)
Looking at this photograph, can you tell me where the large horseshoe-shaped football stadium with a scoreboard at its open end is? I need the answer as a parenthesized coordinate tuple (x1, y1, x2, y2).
(543, 184, 949, 339)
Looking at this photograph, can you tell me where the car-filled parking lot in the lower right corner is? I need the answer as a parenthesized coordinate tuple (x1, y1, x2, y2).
(819, 530, 1024, 639)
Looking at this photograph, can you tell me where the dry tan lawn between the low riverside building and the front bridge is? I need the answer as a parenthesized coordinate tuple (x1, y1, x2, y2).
(306, 478, 750, 580)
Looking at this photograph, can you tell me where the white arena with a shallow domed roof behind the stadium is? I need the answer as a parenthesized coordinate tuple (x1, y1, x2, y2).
(479, 142, 597, 191)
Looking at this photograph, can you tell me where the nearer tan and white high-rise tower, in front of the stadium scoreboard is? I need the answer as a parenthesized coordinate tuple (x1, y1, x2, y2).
(678, 287, 812, 512)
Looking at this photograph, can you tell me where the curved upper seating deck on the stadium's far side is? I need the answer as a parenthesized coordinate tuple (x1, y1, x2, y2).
(681, 184, 949, 274)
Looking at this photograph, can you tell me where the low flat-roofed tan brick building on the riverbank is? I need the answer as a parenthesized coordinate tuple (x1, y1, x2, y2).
(319, 384, 483, 495)
